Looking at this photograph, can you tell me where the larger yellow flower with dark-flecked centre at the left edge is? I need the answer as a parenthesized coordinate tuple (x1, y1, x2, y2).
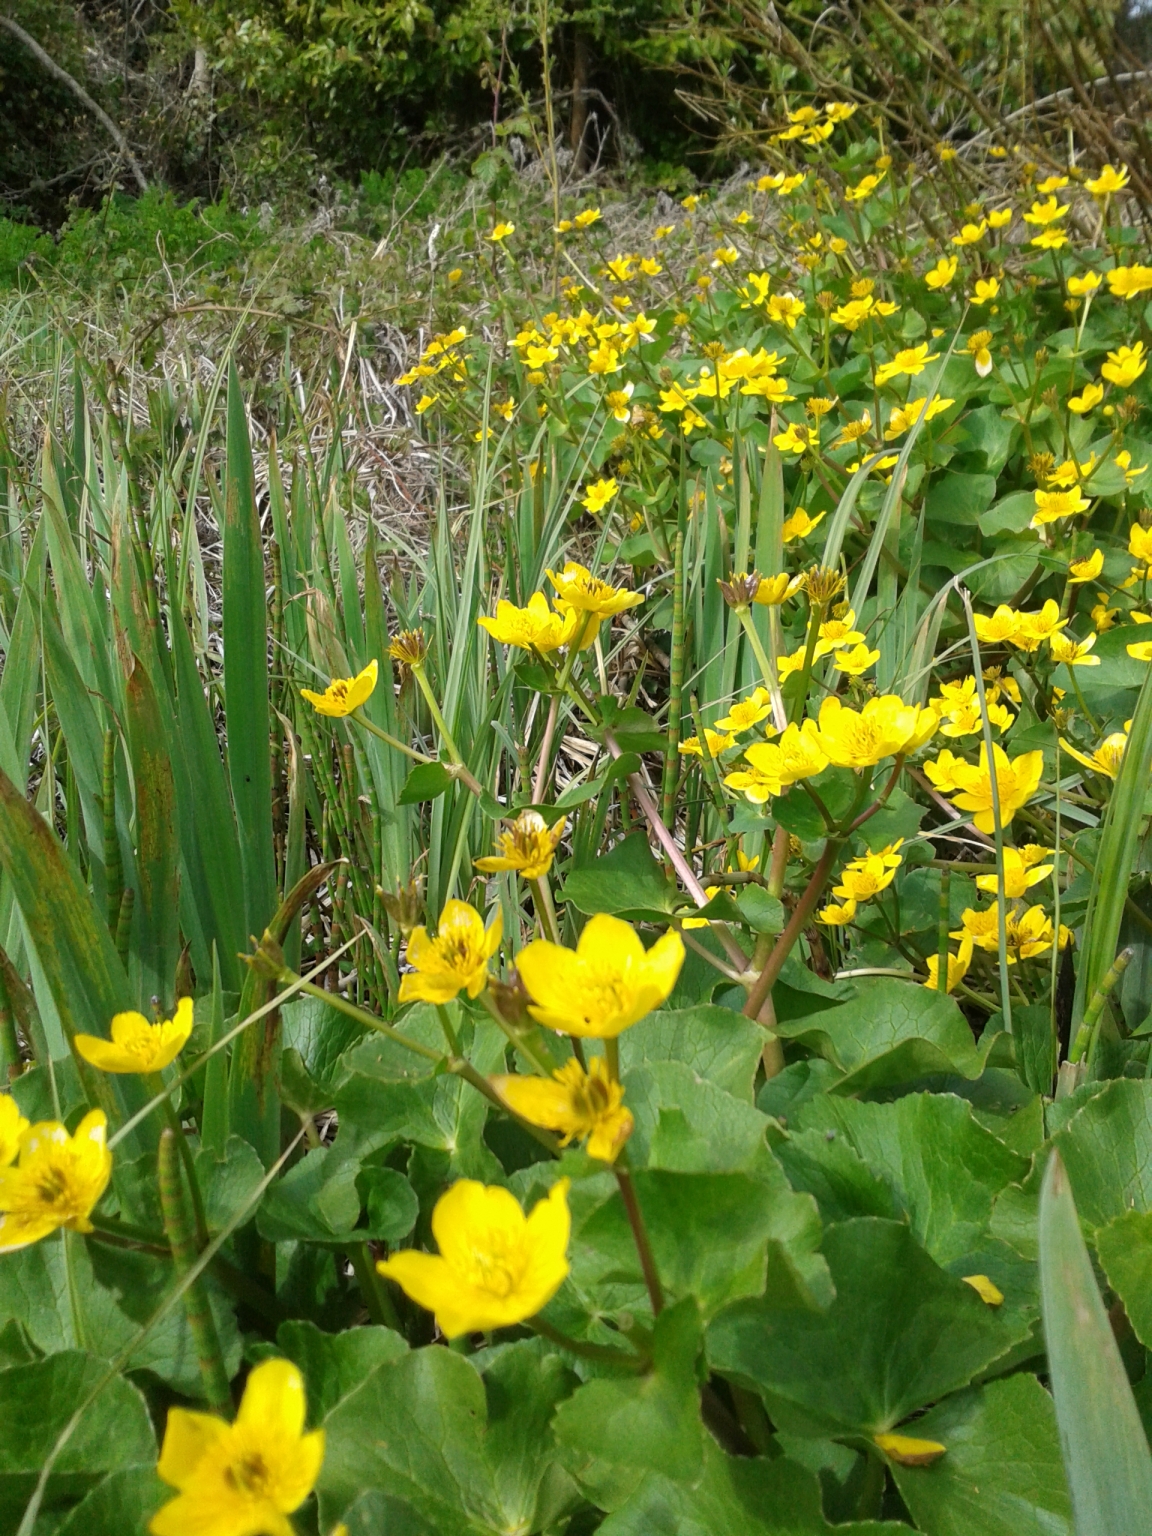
(0, 1109, 112, 1253)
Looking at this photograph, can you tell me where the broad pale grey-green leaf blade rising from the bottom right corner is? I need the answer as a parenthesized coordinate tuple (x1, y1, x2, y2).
(1040, 1152, 1152, 1536)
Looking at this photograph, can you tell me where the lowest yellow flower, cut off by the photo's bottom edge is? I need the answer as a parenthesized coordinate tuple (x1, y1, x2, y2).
(147, 1359, 324, 1536)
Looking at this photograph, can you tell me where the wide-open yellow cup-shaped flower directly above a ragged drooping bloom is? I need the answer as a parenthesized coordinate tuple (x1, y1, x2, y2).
(516, 912, 684, 1040)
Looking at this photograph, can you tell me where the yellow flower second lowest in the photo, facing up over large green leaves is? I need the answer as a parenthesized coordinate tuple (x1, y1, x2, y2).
(376, 1178, 571, 1339)
